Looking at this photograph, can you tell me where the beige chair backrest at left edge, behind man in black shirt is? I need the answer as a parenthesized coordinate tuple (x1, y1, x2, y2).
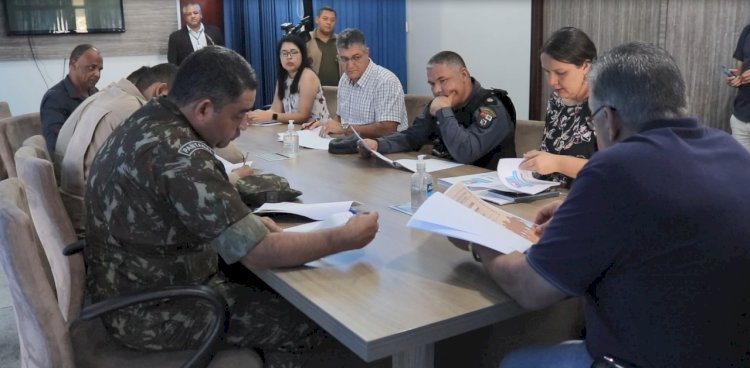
(0, 112, 42, 178)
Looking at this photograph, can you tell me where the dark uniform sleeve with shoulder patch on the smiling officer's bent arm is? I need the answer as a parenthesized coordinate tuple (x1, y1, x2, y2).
(437, 96, 512, 164)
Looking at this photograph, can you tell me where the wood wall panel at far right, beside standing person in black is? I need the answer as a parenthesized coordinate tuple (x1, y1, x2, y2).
(663, 0, 750, 131)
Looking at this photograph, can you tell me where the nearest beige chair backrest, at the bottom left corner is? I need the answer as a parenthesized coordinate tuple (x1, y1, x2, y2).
(0, 178, 73, 367)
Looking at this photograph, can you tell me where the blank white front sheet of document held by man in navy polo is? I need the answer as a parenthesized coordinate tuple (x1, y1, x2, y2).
(406, 192, 531, 254)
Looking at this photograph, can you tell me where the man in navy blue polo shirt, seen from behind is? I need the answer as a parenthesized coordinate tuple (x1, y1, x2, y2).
(464, 43, 750, 367)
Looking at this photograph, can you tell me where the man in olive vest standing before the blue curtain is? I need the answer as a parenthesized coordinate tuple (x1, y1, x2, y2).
(307, 6, 344, 87)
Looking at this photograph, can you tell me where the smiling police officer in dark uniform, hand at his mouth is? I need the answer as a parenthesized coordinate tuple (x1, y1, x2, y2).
(359, 51, 516, 169)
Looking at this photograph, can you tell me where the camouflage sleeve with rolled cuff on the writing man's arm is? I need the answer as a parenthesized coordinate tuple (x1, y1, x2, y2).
(160, 142, 268, 263)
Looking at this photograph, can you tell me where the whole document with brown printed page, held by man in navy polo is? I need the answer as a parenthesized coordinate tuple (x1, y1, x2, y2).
(406, 184, 538, 254)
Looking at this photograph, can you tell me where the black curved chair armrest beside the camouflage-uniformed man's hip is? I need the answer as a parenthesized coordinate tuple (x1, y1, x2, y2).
(80, 286, 229, 368)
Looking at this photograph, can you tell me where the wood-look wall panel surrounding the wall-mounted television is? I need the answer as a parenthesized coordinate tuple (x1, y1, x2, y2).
(0, 0, 177, 61)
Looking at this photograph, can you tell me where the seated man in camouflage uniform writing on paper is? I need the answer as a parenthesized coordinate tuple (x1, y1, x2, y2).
(85, 46, 378, 367)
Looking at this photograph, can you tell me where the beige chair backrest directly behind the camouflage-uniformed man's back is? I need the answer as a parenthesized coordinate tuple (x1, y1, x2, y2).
(15, 147, 85, 321)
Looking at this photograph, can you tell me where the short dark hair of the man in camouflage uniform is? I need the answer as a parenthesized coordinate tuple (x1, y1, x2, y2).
(167, 46, 258, 110)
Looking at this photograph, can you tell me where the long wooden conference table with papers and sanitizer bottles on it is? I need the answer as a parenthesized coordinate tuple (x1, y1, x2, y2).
(235, 125, 564, 367)
